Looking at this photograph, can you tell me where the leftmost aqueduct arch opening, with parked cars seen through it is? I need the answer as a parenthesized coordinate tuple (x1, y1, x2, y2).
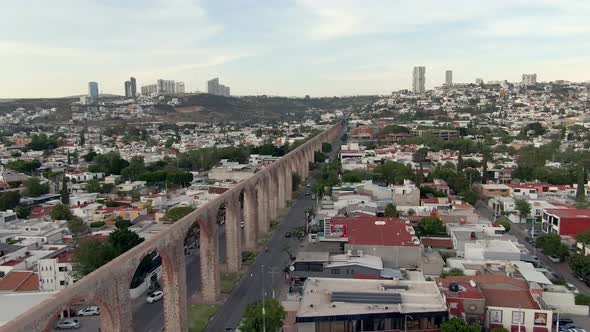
(43, 298, 113, 332)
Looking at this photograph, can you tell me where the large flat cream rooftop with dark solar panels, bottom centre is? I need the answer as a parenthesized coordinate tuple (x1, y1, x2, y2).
(297, 278, 448, 321)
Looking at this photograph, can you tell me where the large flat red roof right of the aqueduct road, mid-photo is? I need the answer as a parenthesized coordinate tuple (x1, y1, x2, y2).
(330, 216, 420, 247)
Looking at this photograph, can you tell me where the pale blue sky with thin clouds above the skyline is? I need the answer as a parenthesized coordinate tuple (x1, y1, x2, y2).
(0, 0, 590, 98)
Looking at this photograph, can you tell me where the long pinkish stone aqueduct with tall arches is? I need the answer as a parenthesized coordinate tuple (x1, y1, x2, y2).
(0, 122, 343, 332)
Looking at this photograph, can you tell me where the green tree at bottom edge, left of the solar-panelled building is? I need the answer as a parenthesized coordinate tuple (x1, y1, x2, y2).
(240, 299, 287, 332)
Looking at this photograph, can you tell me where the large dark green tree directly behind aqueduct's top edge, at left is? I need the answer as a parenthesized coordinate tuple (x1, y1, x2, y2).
(72, 237, 117, 279)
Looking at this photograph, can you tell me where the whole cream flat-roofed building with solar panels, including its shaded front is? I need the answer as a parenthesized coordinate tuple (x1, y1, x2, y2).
(295, 278, 448, 332)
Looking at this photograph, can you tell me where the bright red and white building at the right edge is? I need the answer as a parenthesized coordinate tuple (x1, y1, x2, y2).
(541, 209, 590, 236)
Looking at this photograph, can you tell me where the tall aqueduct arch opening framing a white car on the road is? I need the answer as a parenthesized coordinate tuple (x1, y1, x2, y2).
(129, 250, 166, 331)
